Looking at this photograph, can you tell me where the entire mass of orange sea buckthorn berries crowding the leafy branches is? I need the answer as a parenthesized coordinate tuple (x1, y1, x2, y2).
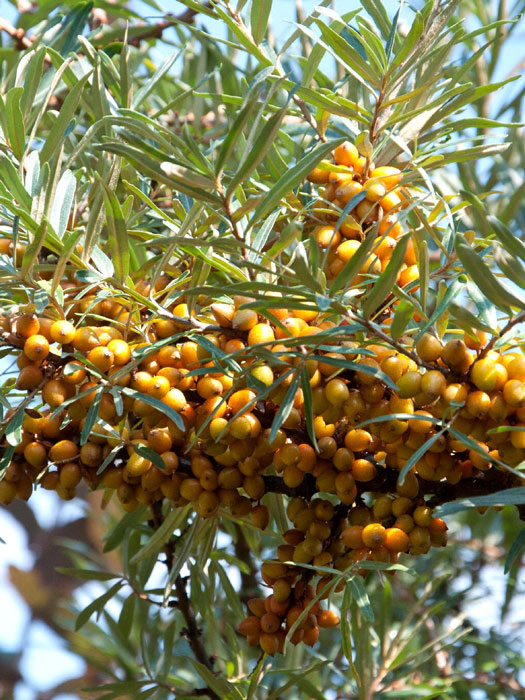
(0, 144, 525, 654)
